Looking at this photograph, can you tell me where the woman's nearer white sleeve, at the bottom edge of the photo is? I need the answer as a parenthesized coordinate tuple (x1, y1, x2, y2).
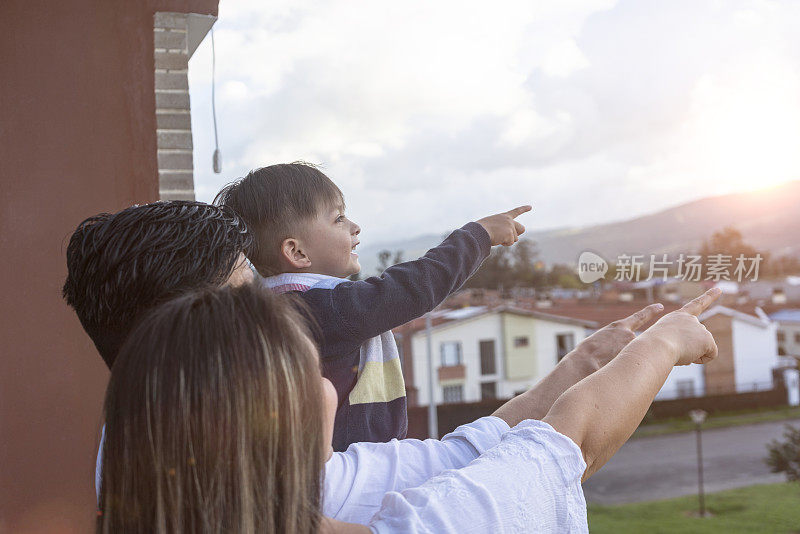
(369, 420, 589, 534)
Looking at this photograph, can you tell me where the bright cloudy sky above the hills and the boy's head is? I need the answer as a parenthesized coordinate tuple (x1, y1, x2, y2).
(189, 0, 800, 247)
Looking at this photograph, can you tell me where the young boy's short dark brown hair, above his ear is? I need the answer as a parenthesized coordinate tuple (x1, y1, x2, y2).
(214, 162, 344, 276)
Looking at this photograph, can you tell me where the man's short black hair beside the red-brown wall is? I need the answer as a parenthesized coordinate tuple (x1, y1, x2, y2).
(63, 200, 252, 368)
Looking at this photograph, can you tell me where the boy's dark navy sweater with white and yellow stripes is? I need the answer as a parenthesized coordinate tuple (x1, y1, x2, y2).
(265, 222, 491, 451)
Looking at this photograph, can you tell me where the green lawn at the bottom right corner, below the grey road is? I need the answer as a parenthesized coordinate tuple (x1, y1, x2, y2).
(589, 483, 800, 534)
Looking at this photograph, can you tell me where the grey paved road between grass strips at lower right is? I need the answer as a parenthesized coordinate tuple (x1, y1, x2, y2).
(583, 419, 800, 504)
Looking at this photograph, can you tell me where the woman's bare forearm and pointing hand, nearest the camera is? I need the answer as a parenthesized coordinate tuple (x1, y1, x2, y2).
(544, 288, 720, 480)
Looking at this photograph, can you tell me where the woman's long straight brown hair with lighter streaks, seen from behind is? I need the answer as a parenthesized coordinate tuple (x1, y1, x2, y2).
(98, 285, 324, 533)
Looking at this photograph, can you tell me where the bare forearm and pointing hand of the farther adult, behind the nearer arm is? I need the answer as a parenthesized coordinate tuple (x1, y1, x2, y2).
(492, 304, 664, 427)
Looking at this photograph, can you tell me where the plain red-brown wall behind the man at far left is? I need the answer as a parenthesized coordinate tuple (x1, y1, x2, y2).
(0, 0, 217, 532)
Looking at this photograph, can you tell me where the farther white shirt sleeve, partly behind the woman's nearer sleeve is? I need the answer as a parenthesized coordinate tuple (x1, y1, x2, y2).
(322, 416, 509, 525)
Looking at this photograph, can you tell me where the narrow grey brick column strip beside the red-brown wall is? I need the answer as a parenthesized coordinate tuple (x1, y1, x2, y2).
(153, 13, 194, 200)
